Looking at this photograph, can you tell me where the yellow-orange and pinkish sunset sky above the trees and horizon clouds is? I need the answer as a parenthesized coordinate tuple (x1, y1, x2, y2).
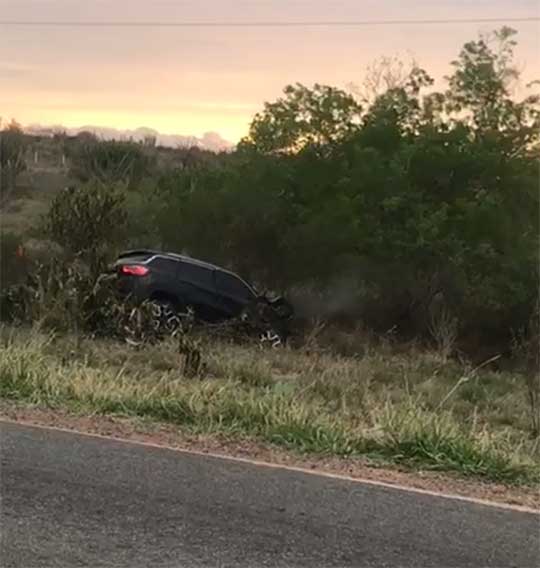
(0, 0, 540, 142)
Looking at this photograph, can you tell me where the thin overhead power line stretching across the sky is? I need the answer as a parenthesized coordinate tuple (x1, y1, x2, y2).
(0, 16, 540, 28)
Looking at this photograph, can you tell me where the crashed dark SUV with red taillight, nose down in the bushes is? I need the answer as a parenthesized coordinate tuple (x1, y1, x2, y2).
(112, 250, 293, 338)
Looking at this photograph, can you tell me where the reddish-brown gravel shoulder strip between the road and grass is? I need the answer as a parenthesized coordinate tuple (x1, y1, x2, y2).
(0, 401, 540, 511)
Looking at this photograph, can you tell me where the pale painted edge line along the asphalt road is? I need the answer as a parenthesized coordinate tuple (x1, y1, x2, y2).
(0, 417, 540, 515)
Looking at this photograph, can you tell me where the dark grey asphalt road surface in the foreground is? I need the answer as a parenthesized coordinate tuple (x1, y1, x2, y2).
(0, 423, 540, 568)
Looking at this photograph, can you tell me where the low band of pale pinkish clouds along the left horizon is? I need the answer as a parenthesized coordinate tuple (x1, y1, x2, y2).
(24, 124, 234, 152)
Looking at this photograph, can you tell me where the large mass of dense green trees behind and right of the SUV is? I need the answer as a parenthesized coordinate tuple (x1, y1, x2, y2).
(144, 28, 540, 346)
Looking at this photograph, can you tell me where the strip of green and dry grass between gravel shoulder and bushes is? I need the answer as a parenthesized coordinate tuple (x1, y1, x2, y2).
(0, 329, 540, 484)
